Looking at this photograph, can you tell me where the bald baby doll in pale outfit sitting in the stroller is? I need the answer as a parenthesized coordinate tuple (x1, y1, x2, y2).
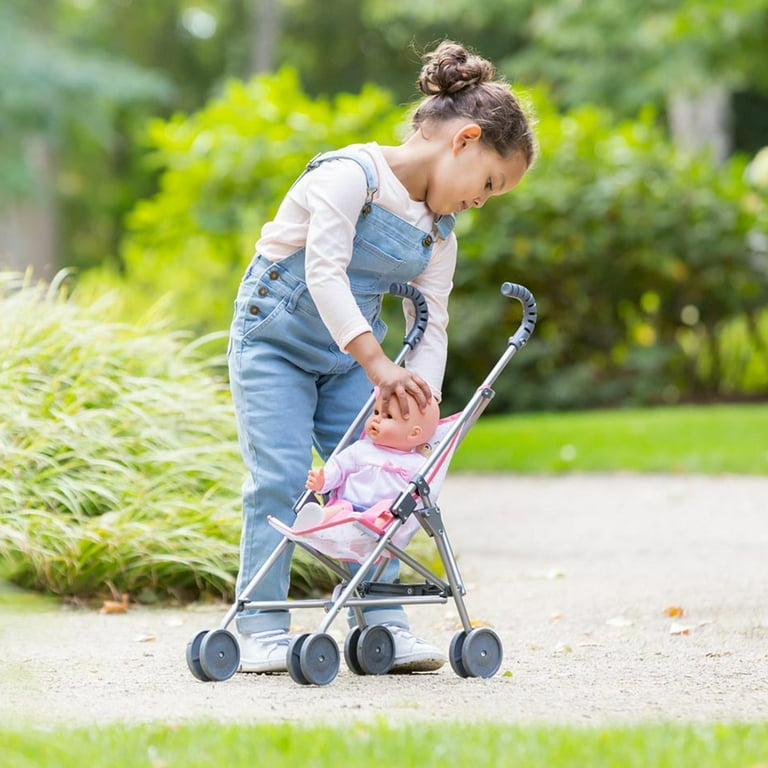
(293, 395, 440, 529)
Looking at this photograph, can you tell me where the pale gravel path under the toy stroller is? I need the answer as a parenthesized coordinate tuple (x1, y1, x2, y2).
(0, 475, 768, 727)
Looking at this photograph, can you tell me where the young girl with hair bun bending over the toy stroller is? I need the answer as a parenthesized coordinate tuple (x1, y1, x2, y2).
(228, 42, 534, 672)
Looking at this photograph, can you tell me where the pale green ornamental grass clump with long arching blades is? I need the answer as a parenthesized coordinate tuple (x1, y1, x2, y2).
(0, 273, 325, 601)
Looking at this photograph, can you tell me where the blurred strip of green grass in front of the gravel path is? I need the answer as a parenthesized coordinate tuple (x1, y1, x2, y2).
(0, 713, 768, 768)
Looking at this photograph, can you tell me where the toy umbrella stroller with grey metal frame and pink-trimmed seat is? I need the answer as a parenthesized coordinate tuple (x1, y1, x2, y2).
(186, 282, 536, 685)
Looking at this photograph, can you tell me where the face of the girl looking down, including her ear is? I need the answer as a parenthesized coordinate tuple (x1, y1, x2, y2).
(425, 124, 528, 215)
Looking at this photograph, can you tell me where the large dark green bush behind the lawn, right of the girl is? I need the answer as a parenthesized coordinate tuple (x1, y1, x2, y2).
(448, 94, 768, 409)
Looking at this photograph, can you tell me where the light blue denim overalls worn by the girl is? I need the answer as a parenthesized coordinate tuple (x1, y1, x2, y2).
(228, 150, 454, 634)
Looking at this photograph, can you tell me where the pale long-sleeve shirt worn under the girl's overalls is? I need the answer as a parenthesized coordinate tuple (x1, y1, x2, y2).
(256, 143, 457, 400)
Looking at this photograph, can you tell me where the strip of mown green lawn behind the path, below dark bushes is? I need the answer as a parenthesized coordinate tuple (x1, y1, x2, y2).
(451, 405, 768, 475)
